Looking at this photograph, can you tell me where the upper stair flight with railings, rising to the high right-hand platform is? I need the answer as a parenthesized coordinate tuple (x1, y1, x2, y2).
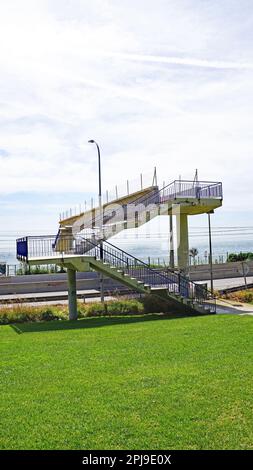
(55, 180, 222, 247)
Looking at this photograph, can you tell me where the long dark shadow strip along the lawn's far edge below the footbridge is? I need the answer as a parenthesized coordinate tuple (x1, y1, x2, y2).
(10, 313, 202, 334)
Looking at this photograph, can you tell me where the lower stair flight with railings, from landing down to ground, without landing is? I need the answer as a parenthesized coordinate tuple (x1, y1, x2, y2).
(77, 239, 216, 313)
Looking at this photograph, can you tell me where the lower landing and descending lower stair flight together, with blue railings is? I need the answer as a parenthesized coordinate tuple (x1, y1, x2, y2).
(17, 236, 216, 313)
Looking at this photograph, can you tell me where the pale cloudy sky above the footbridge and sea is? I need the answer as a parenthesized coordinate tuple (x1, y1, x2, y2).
(0, 0, 253, 235)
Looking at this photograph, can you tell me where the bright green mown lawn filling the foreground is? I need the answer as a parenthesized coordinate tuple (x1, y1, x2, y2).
(0, 315, 253, 449)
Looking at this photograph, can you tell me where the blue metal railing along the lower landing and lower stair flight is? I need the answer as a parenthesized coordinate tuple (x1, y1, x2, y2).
(17, 235, 216, 312)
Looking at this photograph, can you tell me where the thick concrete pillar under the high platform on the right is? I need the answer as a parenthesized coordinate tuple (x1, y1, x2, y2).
(177, 214, 189, 272)
